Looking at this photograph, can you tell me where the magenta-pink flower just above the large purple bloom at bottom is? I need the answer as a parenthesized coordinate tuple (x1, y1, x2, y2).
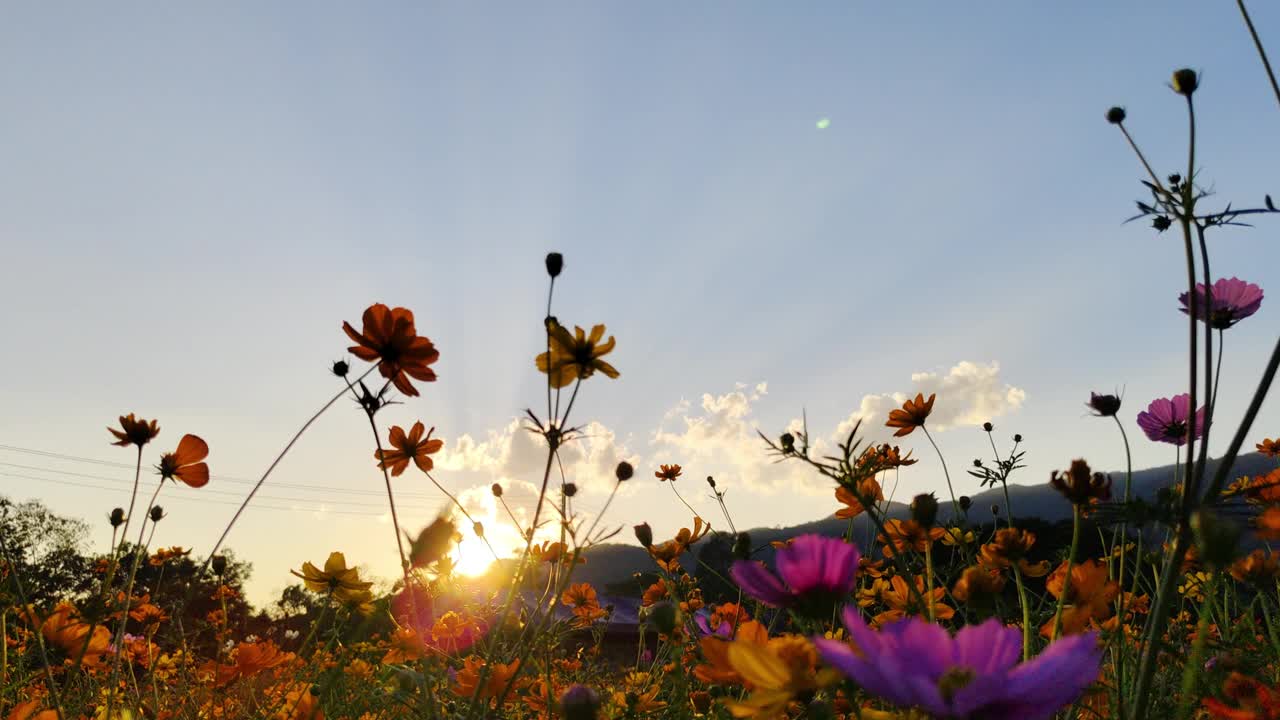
(730, 536, 861, 609)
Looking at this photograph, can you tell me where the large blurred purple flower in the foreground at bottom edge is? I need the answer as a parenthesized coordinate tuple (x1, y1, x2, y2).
(813, 606, 1102, 720)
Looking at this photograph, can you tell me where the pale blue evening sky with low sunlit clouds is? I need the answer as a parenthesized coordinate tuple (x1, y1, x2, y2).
(0, 1, 1280, 602)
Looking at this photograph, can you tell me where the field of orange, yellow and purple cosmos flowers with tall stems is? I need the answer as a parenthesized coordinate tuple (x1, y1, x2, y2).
(15, 5, 1280, 720)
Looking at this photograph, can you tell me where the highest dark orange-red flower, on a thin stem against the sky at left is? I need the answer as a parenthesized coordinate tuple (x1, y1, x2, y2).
(342, 302, 440, 396)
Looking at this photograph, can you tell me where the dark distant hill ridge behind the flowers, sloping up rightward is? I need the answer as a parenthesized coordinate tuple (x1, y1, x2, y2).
(573, 452, 1275, 592)
